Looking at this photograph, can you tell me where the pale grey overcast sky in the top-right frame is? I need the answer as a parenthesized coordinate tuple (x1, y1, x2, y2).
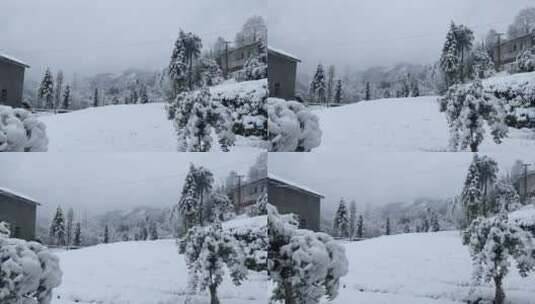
(268, 0, 535, 73)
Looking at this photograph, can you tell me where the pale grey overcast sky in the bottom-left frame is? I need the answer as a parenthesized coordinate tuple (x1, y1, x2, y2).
(0, 152, 257, 215)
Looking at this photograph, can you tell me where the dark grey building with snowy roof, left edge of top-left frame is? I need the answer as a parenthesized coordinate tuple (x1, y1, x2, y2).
(0, 54, 29, 108)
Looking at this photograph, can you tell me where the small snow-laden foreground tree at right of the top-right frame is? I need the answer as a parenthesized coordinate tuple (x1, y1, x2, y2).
(439, 79, 508, 152)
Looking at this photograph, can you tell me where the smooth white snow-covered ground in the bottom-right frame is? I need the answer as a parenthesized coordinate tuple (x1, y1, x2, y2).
(325, 231, 535, 304)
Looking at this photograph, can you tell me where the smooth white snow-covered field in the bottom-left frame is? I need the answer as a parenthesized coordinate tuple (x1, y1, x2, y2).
(52, 240, 268, 304)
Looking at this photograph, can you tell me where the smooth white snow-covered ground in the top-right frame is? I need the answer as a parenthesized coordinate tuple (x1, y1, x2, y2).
(314, 96, 535, 153)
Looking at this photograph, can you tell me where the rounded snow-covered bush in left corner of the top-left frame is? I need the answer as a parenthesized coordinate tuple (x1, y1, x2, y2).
(0, 106, 48, 152)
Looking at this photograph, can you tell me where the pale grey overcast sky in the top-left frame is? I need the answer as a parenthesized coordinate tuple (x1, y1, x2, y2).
(0, 0, 267, 77)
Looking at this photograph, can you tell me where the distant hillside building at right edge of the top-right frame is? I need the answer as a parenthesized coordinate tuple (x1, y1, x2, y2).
(491, 33, 535, 71)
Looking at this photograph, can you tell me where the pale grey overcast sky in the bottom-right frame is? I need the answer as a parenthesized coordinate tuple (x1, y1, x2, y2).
(269, 151, 535, 211)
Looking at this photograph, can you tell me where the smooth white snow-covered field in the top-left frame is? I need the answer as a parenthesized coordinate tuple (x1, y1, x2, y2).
(39, 103, 264, 152)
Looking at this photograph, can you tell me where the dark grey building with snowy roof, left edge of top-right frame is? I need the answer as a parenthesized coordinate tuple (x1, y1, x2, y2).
(268, 47, 301, 100)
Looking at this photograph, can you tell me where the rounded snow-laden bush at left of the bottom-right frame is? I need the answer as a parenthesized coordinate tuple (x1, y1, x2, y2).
(268, 205, 348, 304)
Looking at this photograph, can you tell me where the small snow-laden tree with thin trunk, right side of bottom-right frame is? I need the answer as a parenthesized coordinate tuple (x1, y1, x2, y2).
(463, 213, 535, 304)
